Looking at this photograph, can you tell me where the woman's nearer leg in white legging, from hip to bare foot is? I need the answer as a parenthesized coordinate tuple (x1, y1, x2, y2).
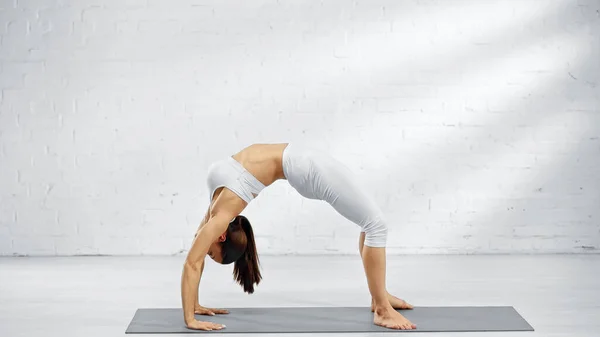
(283, 145, 415, 329)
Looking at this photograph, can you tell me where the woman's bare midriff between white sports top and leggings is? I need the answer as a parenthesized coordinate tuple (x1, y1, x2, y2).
(232, 143, 287, 186)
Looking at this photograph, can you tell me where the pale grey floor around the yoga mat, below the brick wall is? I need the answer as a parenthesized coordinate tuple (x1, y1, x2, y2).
(0, 255, 600, 337)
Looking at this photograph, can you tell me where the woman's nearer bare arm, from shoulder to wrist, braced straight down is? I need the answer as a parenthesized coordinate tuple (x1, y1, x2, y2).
(181, 212, 231, 327)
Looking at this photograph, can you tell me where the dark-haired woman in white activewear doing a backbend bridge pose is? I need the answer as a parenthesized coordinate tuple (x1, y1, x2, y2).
(181, 144, 416, 330)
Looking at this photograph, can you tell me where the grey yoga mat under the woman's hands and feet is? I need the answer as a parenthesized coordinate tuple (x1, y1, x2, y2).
(126, 307, 533, 333)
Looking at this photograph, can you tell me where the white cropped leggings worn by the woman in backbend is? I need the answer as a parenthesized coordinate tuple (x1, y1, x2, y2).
(283, 144, 387, 247)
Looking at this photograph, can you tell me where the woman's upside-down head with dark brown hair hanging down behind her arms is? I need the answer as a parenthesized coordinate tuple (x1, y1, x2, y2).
(221, 215, 262, 294)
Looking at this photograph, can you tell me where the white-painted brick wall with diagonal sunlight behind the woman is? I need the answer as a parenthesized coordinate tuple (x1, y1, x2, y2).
(0, 0, 600, 255)
